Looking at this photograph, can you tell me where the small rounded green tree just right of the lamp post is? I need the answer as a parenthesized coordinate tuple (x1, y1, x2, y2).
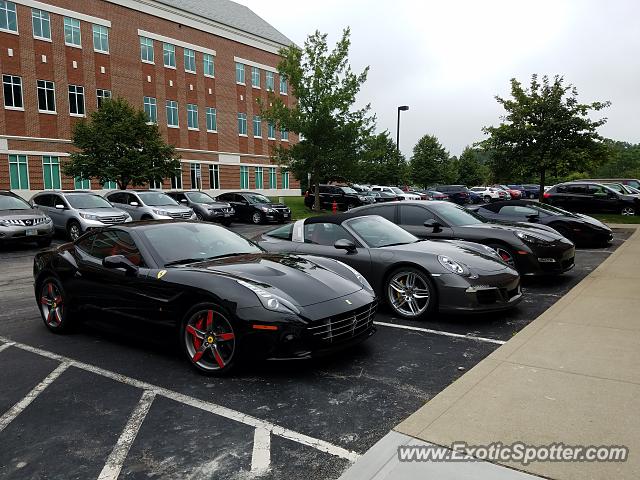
(409, 135, 456, 188)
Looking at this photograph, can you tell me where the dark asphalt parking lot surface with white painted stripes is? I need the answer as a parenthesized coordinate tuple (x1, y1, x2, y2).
(0, 225, 628, 479)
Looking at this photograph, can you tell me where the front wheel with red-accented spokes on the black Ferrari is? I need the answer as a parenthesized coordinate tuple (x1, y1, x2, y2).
(180, 303, 238, 375)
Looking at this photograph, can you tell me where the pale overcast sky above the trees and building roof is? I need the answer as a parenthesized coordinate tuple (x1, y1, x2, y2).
(236, 0, 640, 157)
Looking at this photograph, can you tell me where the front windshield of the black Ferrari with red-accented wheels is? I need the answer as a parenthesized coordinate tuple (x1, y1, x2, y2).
(140, 223, 263, 266)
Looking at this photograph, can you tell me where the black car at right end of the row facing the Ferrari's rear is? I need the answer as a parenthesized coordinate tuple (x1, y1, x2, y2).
(216, 192, 291, 225)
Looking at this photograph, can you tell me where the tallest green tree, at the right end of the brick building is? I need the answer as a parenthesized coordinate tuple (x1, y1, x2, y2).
(260, 28, 374, 210)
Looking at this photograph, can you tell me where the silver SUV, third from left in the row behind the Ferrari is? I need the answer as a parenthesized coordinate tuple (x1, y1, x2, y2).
(105, 190, 196, 220)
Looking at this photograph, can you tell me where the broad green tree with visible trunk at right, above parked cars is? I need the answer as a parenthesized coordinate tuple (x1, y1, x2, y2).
(481, 74, 610, 198)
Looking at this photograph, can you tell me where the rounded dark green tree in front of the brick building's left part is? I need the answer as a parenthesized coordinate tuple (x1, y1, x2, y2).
(63, 98, 180, 190)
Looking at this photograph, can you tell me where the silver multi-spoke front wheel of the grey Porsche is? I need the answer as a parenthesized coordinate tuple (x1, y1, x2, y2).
(386, 267, 436, 320)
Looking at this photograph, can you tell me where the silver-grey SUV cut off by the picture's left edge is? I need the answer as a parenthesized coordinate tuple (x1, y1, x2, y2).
(0, 190, 54, 247)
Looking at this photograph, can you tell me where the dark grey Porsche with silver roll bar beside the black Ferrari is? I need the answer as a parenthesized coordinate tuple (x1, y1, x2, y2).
(259, 213, 522, 319)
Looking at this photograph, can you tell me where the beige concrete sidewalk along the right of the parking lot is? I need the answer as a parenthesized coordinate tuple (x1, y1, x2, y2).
(341, 225, 640, 480)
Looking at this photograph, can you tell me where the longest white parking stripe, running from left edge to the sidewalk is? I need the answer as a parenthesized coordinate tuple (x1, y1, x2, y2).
(0, 337, 360, 462)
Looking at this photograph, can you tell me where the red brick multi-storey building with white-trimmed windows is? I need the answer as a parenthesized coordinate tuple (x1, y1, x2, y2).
(0, 0, 300, 198)
